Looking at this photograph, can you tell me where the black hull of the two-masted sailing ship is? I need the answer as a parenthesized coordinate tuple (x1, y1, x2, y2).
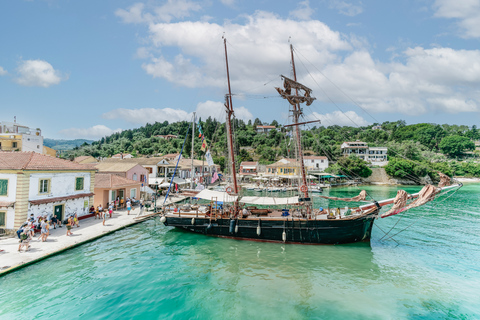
(164, 210, 378, 244)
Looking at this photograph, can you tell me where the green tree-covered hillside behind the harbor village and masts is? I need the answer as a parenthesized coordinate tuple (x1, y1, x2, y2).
(62, 117, 480, 177)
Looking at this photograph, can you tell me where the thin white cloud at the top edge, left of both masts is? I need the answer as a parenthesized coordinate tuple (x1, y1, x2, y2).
(115, 0, 202, 23)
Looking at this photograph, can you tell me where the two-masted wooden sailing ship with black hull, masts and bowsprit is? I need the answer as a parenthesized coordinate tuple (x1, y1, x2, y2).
(160, 38, 461, 244)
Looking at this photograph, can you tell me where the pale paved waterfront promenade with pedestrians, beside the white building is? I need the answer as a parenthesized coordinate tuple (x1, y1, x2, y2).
(0, 196, 185, 276)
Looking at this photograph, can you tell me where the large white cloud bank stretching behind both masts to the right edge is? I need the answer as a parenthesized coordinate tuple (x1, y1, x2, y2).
(120, 5, 480, 120)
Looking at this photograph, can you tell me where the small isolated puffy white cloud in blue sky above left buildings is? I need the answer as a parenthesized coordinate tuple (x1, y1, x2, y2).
(15, 60, 68, 88)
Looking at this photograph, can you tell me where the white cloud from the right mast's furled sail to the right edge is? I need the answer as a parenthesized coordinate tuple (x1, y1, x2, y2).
(307, 47, 480, 115)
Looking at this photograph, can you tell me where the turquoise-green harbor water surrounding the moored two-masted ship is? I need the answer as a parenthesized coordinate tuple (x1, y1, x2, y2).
(0, 184, 480, 319)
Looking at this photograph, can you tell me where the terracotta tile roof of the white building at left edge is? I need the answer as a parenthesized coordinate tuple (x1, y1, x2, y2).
(0, 151, 95, 171)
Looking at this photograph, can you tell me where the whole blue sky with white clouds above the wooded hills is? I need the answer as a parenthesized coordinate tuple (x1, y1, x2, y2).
(0, 0, 480, 139)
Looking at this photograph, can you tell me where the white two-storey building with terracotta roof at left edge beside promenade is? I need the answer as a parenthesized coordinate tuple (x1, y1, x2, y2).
(0, 152, 96, 230)
